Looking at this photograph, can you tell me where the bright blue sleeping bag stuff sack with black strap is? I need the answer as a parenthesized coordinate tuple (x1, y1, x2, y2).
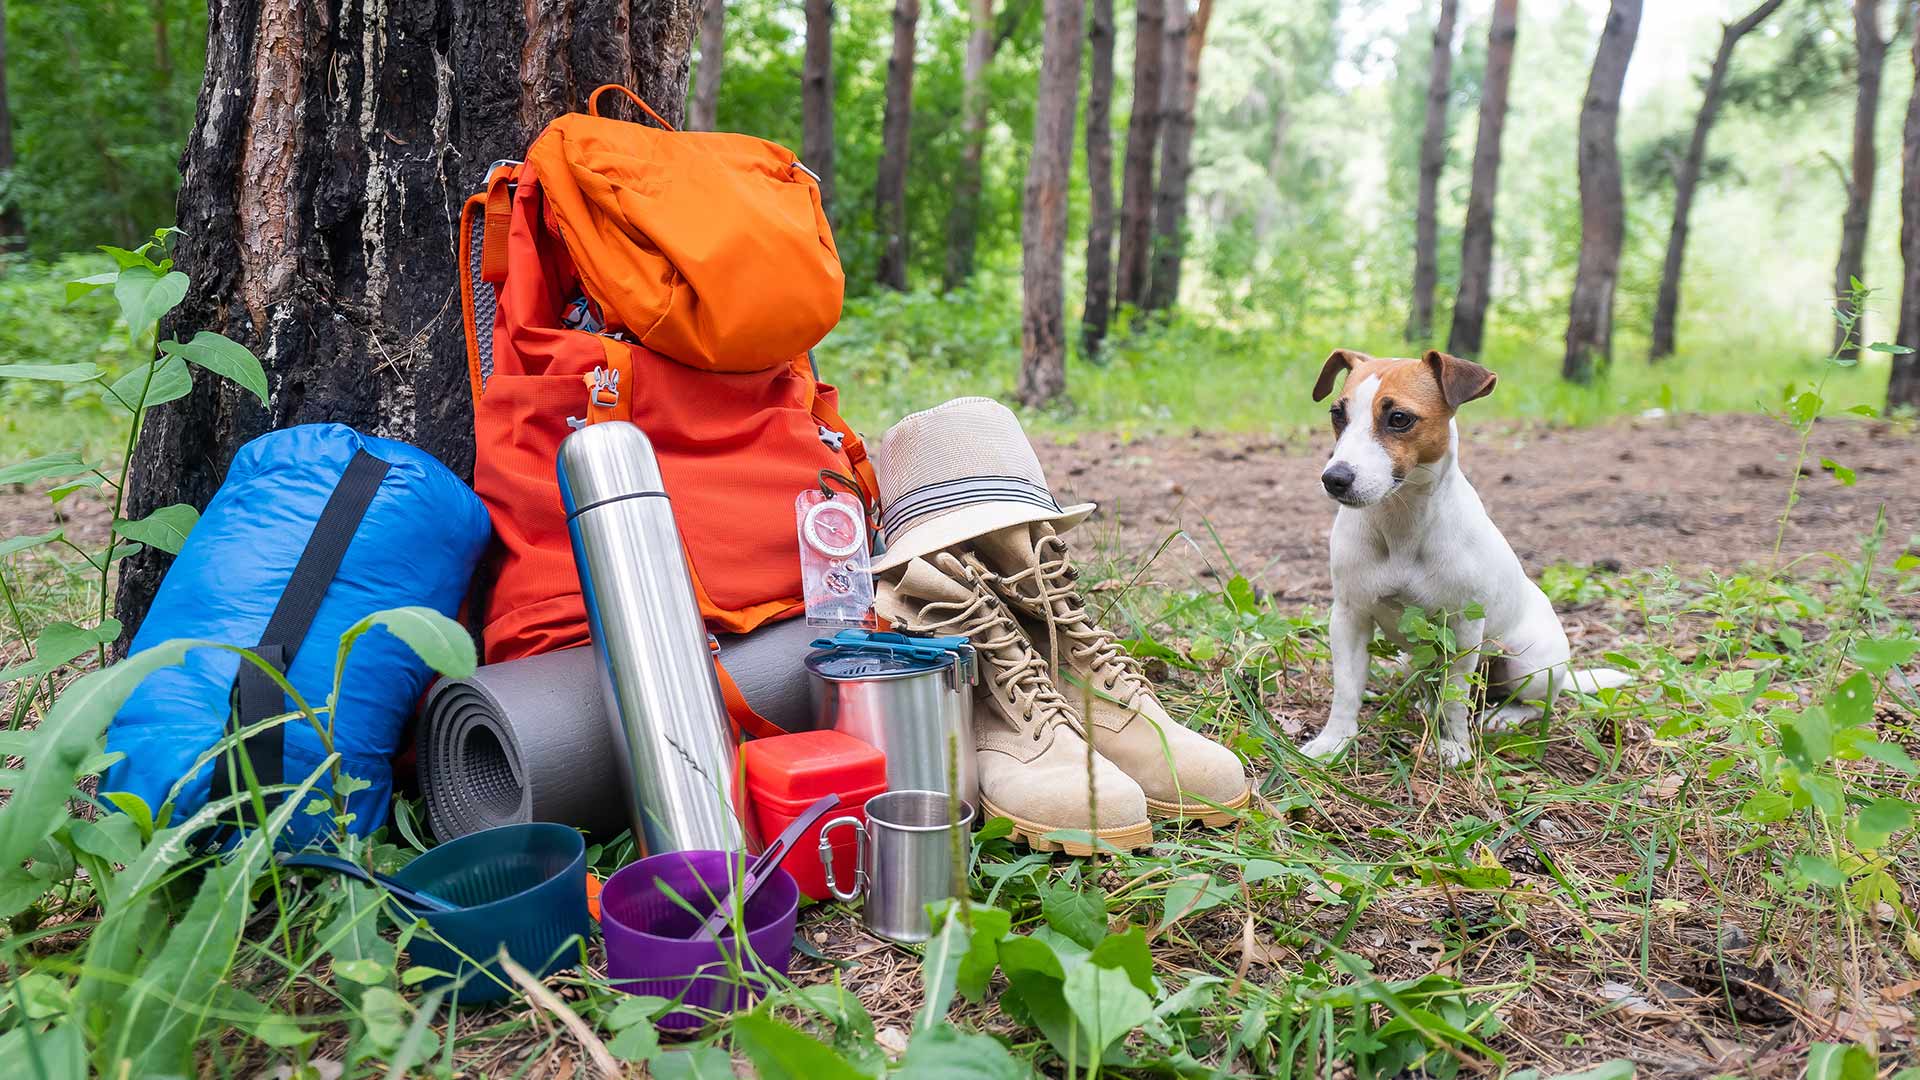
(100, 425, 492, 846)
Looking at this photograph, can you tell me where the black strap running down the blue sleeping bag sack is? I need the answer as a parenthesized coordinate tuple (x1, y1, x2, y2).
(207, 450, 388, 826)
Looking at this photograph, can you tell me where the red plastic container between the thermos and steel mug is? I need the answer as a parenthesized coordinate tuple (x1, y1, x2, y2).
(739, 732, 887, 899)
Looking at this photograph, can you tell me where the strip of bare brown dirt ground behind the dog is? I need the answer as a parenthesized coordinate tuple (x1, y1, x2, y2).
(1039, 415, 1920, 601)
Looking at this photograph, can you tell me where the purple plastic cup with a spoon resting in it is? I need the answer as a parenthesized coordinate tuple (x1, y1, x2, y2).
(601, 851, 801, 1032)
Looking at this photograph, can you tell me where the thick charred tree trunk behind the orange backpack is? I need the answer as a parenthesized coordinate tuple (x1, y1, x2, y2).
(119, 0, 695, 630)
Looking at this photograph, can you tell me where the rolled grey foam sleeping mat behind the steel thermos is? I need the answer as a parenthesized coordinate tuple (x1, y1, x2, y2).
(419, 619, 820, 842)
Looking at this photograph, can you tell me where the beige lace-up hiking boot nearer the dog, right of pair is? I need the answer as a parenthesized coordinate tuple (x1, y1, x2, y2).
(966, 523, 1252, 824)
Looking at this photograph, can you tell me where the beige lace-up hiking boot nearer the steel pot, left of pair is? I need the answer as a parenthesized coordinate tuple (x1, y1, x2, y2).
(876, 553, 1154, 855)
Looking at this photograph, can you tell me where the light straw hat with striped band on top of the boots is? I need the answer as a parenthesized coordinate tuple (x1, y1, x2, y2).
(874, 390, 1094, 573)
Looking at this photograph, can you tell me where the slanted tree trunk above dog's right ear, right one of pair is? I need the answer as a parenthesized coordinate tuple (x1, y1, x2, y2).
(1446, 0, 1521, 356)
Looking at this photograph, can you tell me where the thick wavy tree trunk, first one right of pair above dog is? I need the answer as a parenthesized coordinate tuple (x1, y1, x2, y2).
(1561, 0, 1640, 382)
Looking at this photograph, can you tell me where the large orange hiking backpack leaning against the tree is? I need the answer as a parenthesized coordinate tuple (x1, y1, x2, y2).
(461, 86, 877, 730)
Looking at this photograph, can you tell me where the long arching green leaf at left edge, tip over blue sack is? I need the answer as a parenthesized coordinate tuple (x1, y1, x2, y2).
(0, 640, 209, 867)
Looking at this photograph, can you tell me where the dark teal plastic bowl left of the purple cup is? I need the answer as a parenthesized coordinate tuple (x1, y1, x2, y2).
(394, 822, 593, 1005)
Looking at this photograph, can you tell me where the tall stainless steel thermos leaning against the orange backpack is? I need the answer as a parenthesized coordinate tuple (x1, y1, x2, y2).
(557, 421, 758, 855)
